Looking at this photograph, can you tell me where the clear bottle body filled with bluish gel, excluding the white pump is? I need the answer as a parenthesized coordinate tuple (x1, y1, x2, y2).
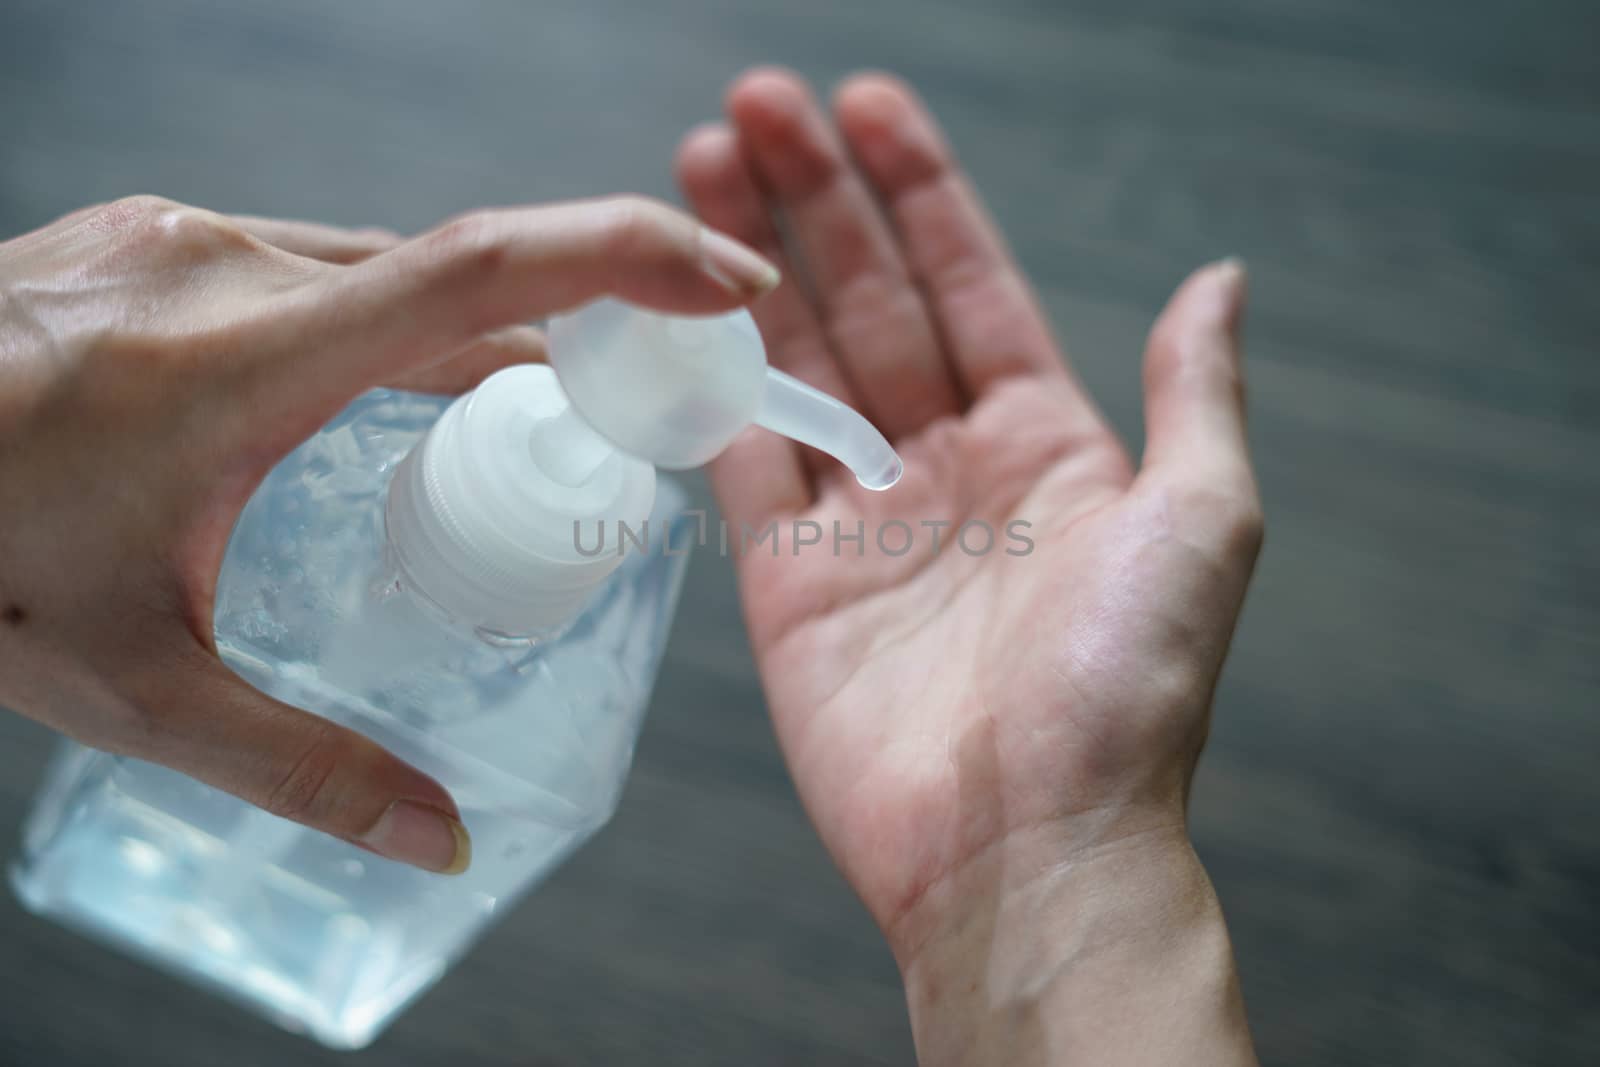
(11, 390, 686, 1048)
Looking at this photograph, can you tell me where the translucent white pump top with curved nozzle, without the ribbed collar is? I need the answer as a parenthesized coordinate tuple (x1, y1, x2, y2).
(550, 301, 902, 490)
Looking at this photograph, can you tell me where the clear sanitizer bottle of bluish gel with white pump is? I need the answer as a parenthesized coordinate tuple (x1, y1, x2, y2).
(11, 301, 901, 1048)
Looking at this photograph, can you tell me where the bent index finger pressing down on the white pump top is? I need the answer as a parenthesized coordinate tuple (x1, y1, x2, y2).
(274, 197, 778, 403)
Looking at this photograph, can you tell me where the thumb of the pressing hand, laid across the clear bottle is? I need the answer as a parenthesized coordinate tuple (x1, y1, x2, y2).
(131, 651, 472, 873)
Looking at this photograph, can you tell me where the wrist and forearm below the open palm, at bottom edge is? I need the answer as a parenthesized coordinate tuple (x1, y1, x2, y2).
(902, 833, 1256, 1067)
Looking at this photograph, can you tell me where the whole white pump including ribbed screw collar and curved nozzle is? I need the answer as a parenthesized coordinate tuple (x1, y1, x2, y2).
(387, 301, 901, 635)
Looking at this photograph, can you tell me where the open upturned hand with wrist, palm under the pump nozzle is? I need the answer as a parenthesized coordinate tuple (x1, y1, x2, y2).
(678, 70, 1262, 1064)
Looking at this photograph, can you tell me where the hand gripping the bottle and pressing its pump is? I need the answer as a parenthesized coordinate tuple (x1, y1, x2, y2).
(0, 197, 776, 872)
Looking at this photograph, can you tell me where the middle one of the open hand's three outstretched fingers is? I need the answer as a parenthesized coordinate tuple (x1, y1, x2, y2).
(728, 69, 960, 437)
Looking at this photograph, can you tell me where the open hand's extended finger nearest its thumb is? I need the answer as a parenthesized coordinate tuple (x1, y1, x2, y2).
(834, 74, 1088, 405)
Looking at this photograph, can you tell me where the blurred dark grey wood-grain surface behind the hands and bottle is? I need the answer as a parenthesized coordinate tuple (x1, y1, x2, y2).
(0, 0, 1600, 1067)
